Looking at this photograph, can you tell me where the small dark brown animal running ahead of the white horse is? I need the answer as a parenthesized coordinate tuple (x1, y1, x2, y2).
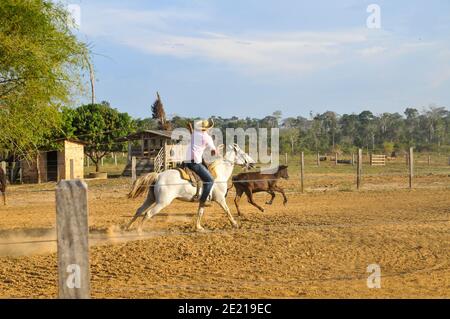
(233, 165, 289, 215)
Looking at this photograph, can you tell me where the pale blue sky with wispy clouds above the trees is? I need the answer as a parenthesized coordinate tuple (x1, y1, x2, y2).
(70, 0, 450, 117)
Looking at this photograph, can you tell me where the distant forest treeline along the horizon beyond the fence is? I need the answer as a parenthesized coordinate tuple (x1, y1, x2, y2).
(135, 106, 450, 154)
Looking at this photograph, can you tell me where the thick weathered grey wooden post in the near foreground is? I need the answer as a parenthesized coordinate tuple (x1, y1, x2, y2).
(56, 180, 90, 299)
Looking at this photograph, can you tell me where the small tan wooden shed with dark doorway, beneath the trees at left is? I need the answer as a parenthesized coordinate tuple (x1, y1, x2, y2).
(20, 139, 86, 183)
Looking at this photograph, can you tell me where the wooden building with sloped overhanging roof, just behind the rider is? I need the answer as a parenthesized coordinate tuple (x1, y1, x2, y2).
(118, 130, 186, 176)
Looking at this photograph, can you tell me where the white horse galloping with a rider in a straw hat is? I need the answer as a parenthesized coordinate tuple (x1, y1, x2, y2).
(127, 144, 255, 231)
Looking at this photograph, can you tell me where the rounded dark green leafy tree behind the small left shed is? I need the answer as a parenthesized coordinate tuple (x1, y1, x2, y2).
(63, 102, 135, 172)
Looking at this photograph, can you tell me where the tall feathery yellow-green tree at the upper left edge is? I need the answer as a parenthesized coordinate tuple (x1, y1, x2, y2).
(0, 0, 87, 158)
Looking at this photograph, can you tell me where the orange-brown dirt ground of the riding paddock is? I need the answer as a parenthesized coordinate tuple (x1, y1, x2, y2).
(0, 175, 450, 298)
